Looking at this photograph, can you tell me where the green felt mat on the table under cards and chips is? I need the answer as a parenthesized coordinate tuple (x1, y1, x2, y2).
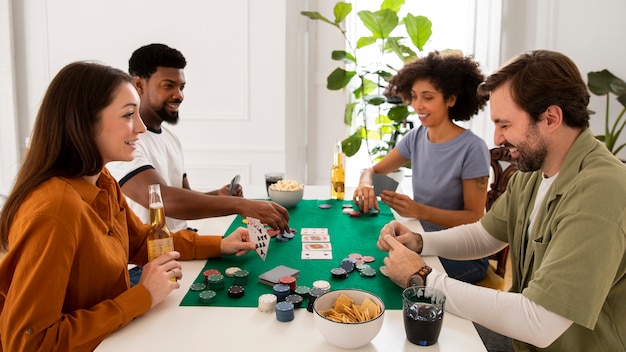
(180, 200, 402, 309)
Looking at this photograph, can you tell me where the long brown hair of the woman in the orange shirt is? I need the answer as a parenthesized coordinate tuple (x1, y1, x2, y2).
(0, 61, 132, 251)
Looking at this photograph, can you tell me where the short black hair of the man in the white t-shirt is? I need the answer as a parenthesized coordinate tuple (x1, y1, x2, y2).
(128, 44, 187, 78)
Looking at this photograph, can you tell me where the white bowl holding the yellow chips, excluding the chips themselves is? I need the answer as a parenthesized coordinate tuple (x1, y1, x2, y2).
(313, 289, 385, 349)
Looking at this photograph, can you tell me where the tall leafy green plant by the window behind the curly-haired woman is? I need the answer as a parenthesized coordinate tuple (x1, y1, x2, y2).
(301, 0, 432, 163)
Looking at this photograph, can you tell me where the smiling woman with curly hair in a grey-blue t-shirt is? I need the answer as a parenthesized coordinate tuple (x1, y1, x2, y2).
(353, 51, 489, 283)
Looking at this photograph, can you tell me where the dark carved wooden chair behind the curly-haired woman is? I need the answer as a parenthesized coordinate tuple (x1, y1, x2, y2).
(478, 147, 517, 290)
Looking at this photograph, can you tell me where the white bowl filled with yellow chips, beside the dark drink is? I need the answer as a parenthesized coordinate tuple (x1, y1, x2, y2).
(313, 289, 385, 349)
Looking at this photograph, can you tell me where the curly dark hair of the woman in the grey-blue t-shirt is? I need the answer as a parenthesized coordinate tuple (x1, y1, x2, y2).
(386, 51, 488, 121)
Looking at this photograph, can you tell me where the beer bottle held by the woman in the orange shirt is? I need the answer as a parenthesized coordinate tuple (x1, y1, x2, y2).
(148, 184, 176, 281)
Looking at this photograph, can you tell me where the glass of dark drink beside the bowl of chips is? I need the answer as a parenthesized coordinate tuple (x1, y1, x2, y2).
(402, 286, 446, 346)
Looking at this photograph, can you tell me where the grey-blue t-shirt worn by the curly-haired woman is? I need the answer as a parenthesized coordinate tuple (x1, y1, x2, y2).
(396, 126, 490, 231)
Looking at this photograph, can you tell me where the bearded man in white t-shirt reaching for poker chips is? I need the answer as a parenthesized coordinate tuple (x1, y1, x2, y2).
(107, 44, 289, 284)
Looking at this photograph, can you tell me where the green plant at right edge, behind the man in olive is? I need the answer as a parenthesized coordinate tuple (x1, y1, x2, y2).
(587, 70, 626, 155)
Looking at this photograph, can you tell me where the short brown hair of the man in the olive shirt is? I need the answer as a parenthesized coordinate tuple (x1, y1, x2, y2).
(478, 50, 589, 129)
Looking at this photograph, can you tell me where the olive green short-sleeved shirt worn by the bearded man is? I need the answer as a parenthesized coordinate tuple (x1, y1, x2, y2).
(481, 130, 626, 352)
